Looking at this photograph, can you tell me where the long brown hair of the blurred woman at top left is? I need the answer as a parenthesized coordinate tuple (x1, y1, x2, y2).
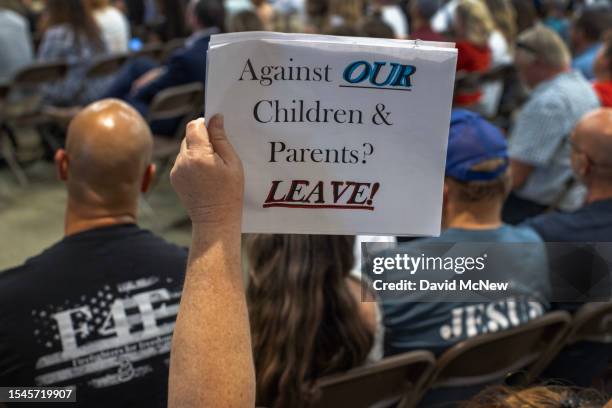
(47, 0, 104, 50)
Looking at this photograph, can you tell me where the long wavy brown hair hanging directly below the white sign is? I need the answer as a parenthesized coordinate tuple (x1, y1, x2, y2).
(246, 235, 373, 408)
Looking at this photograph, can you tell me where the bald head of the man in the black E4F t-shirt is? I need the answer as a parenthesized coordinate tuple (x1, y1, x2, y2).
(56, 99, 153, 209)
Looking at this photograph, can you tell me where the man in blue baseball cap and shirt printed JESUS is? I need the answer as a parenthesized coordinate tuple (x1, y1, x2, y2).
(377, 109, 550, 355)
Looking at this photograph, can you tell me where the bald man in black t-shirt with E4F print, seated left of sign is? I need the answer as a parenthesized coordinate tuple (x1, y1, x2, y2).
(0, 99, 187, 407)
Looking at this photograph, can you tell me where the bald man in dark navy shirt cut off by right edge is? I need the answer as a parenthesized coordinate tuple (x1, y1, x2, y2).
(527, 108, 612, 242)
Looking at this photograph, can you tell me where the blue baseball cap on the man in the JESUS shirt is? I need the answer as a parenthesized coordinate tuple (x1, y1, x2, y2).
(446, 109, 509, 182)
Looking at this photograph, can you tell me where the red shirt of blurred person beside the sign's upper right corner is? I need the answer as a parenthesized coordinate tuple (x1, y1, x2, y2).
(453, 41, 491, 106)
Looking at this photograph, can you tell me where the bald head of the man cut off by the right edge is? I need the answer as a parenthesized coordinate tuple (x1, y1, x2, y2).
(572, 108, 612, 186)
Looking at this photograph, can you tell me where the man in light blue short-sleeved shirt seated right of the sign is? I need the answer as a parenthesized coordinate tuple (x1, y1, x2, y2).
(503, 26, 599, 224)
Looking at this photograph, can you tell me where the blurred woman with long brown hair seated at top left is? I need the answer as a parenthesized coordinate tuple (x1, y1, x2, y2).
(38, 0, 108, 106)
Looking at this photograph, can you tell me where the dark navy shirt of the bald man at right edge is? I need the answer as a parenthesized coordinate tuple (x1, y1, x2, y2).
(524, 200, 612, 242)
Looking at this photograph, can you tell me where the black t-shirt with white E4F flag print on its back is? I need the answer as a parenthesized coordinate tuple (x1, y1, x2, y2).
(0, 224, 187, 408)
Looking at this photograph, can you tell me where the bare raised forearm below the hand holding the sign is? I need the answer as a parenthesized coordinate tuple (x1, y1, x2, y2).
(169, 221, 255, 408)
